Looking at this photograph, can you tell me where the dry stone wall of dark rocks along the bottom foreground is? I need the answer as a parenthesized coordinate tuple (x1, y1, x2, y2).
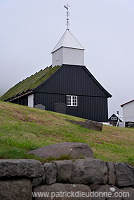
(0, 158, 134, 200)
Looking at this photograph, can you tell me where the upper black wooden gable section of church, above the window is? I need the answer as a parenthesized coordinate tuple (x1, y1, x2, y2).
(38, 65, 107, 97)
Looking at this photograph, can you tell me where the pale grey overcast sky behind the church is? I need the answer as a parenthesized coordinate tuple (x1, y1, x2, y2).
(0, 0, 134, 115)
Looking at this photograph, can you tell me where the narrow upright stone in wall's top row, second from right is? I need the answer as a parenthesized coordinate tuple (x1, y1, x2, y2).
(107, 162, 116, 185)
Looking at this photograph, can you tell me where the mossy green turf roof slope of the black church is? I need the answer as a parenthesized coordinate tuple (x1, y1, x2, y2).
(0, 66, 59, 101)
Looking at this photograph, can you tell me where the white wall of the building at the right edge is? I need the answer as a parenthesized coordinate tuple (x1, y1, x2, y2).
(123, 101, 134, 122)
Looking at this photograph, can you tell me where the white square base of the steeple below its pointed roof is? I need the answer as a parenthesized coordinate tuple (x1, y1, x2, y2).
(52, 47, 84, 67)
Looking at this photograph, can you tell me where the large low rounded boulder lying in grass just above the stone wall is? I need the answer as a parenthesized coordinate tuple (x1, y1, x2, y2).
(29, 142, 93, 159)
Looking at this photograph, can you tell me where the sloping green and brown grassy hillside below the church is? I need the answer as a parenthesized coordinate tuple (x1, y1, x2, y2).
(0, 101, 134, 165)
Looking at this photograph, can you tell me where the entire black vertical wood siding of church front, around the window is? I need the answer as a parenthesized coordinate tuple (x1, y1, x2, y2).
(34, 65, 110, 122)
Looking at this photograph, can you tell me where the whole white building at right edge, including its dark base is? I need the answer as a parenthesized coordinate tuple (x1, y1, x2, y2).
(121, 100, 134, 126)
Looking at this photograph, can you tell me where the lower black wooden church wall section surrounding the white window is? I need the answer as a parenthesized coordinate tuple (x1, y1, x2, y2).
(34, 93, 108, 122)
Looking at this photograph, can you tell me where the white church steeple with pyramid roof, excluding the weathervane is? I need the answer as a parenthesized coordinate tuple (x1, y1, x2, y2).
(52, 29, 84, 67)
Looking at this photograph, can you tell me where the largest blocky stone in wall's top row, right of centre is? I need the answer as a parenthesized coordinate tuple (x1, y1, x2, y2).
(72, 159, 108, 185)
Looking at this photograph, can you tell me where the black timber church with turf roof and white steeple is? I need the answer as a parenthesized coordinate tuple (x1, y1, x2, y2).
(1, 29, 111, 122)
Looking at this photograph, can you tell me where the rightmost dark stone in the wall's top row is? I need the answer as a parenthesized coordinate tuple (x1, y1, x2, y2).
(115, 163, 134, 187)
